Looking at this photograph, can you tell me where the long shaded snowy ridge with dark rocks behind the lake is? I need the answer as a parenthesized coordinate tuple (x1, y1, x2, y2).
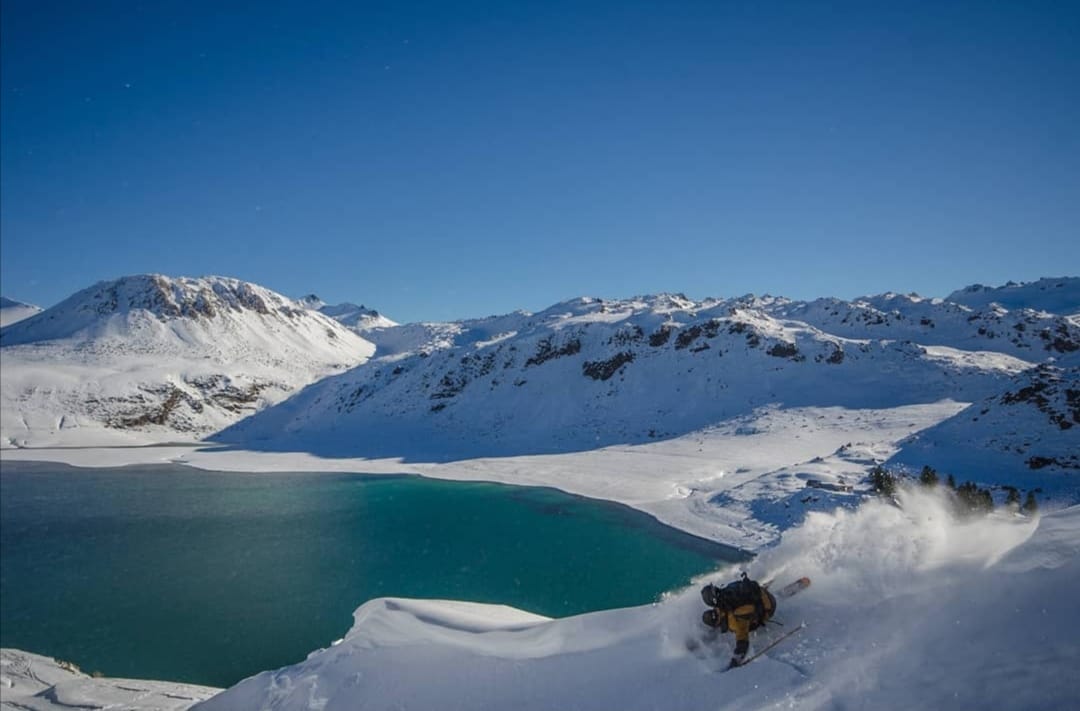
(217, 287, 1067, 458)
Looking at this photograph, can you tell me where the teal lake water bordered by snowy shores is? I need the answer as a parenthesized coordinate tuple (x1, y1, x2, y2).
(0, 462, 735, 686)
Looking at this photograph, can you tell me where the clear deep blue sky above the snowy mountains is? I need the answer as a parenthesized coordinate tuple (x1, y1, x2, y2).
(0, 0, 1080, 321)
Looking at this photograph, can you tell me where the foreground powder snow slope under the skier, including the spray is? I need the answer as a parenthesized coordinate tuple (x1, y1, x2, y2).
(195, 493, 1080, 711)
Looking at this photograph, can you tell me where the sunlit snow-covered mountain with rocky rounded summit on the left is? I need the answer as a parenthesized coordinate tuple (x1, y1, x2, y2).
(0, 274, 375, 446)
